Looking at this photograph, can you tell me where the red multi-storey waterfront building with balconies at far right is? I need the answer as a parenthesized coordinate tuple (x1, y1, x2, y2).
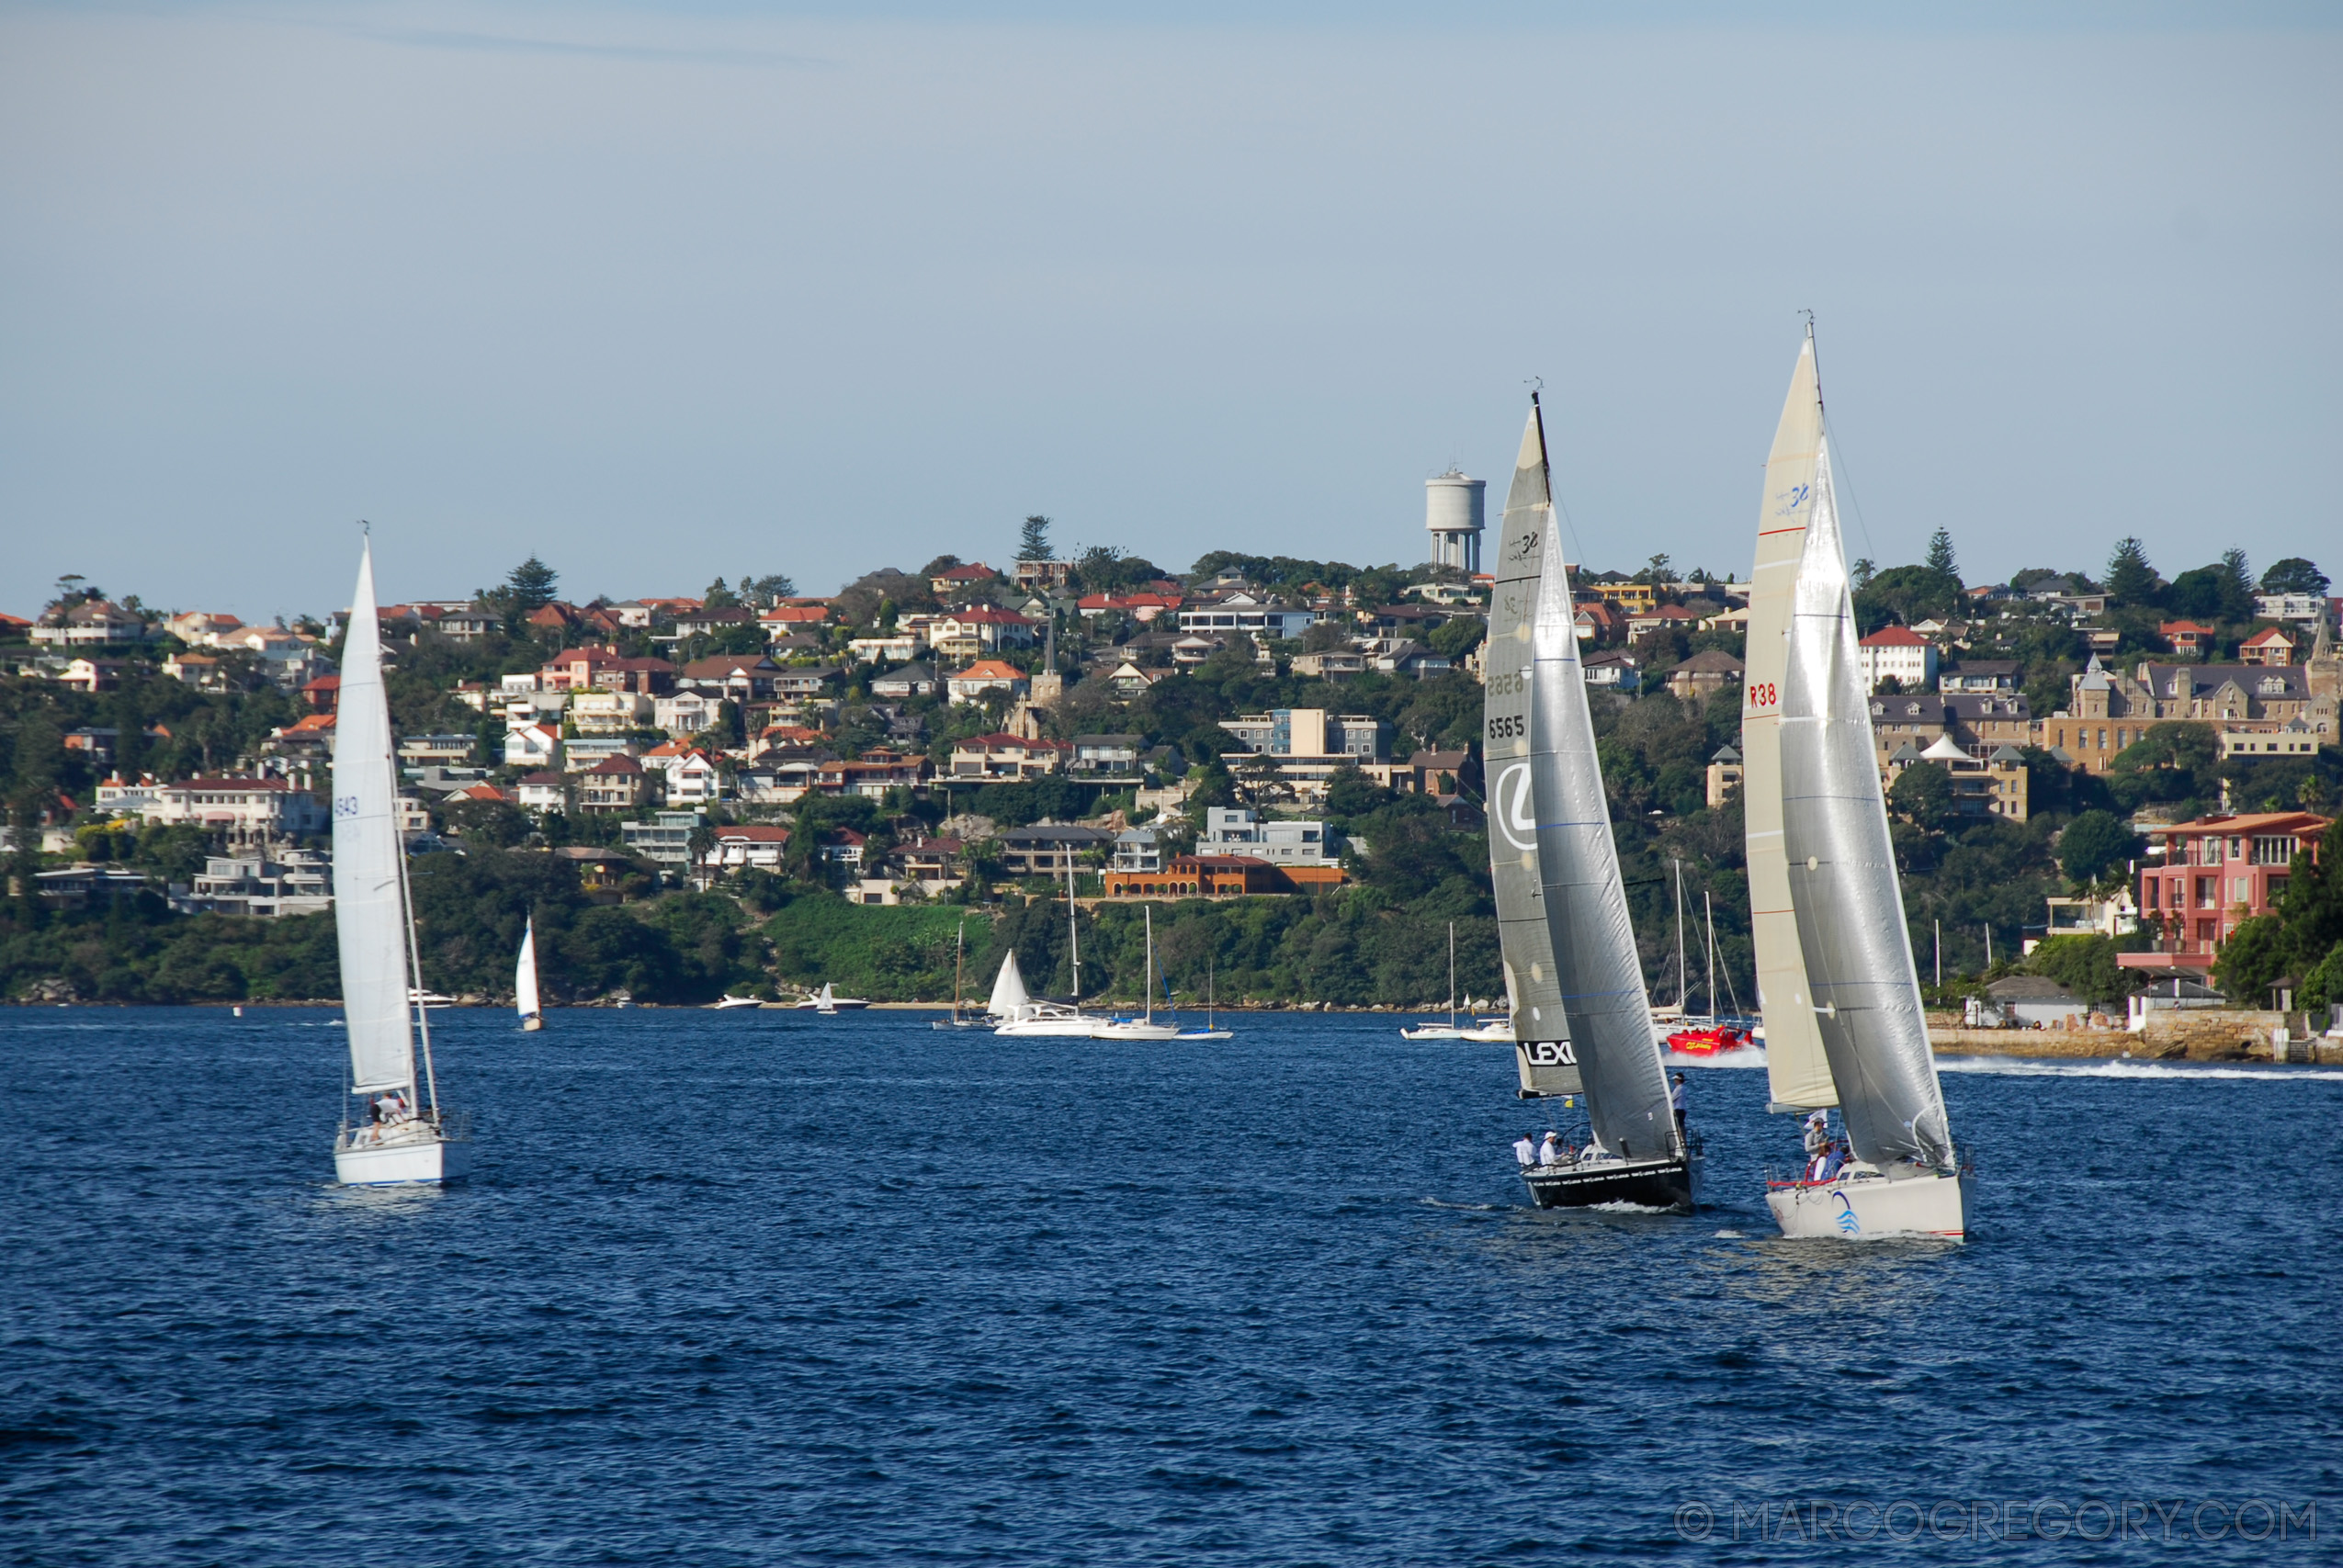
(2116, 811, 2329, 975)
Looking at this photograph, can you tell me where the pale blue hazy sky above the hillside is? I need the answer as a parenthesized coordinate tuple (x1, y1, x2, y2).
(0, 3, 2343, 616)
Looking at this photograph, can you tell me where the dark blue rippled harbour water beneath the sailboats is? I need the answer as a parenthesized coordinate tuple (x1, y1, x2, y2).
(0, 1008, 2343, 1565)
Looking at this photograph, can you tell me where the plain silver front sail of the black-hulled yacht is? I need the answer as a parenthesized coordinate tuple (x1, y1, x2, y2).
(1504, 399, 1678, 1160)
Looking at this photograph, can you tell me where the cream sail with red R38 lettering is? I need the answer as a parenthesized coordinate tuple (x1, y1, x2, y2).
(1741, 333, 1839, 1111)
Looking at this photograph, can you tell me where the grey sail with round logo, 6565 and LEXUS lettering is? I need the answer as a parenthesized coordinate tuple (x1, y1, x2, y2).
(1481, 408, 1581, 1100)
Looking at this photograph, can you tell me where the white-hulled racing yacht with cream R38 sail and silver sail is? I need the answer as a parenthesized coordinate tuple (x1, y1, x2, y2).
(1741, 326, 1968, 1240)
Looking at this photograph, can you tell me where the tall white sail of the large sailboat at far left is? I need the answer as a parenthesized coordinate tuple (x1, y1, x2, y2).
(333, 541, 414, 1100)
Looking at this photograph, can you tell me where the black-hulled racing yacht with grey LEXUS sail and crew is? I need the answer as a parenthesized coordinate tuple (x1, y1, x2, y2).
(1483, 394, 1696, 1212)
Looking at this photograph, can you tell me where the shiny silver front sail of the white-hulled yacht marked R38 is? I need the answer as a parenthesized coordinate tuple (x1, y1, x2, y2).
(1752, 441, 1954, 1169)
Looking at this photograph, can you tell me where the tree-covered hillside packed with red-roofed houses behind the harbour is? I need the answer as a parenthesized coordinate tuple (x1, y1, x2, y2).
(0, 518, 2343, 1010)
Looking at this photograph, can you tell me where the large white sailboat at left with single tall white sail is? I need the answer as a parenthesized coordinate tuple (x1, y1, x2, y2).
(333, 539, 471, 1186)
